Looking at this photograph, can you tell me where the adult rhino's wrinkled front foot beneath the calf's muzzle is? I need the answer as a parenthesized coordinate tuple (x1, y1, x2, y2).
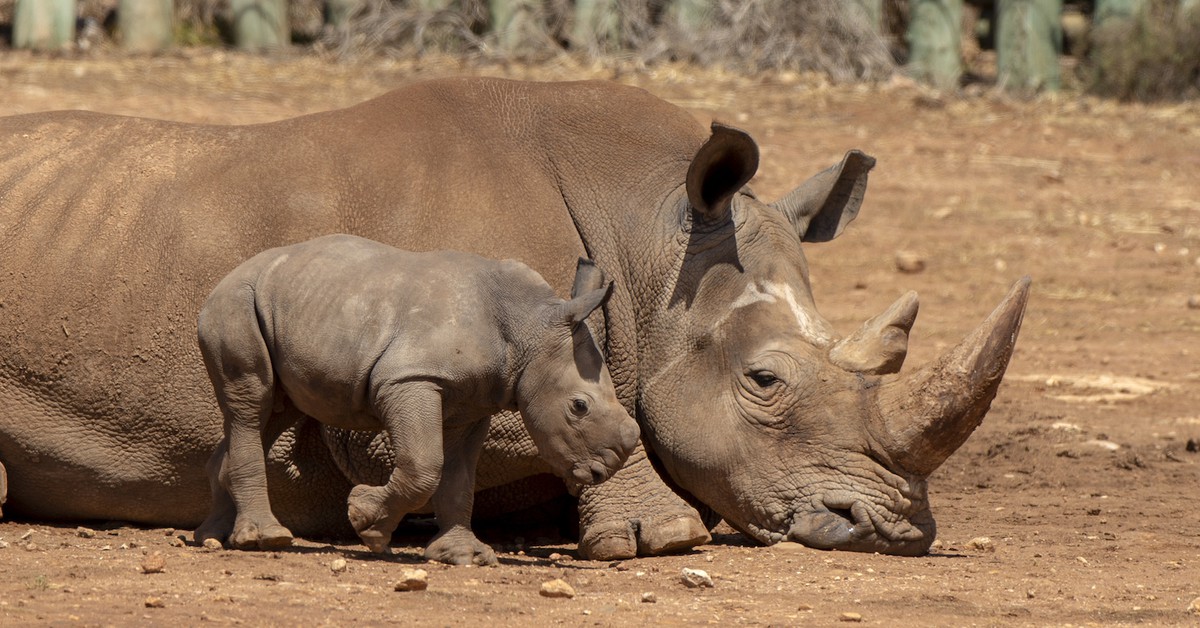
(580, 443, 712, 561)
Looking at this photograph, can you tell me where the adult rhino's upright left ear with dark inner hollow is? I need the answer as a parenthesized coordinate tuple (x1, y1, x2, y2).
(686, 122, 758, 221)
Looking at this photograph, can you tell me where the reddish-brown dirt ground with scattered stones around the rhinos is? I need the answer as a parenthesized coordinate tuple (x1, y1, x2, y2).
(0, 52, 1200, 626)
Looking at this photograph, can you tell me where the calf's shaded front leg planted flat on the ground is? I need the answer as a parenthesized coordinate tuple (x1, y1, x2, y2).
(425, 419, 497, 566)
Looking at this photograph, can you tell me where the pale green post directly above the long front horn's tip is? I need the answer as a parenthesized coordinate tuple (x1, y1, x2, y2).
(996, 0, 1062, 91)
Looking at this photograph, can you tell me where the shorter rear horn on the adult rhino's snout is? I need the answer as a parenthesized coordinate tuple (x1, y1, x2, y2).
(829, 292, 918, 375)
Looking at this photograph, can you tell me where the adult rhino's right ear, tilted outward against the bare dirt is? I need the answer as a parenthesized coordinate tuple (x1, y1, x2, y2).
(773, 150, 875, 243)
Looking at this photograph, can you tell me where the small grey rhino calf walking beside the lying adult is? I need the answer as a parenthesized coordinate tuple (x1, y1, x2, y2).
(196, 235, 638, 564)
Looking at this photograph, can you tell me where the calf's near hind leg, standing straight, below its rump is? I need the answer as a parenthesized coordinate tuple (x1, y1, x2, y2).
(196, 282, 292, 550)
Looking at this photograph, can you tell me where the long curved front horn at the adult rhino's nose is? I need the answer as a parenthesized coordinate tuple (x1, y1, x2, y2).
(877, 277, 1030, 476)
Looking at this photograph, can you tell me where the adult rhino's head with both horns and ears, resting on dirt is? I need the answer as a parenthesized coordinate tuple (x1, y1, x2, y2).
(637, 124, 1030, 555)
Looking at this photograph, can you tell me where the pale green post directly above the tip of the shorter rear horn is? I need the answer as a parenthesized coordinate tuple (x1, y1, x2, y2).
(905, 0, 962, 89)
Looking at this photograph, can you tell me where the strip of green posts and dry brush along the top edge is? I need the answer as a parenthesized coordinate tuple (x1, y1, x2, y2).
(0, 0, 1200, 100)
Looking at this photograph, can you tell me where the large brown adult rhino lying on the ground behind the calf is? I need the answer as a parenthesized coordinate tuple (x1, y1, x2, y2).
(0, 79, 1027, 557)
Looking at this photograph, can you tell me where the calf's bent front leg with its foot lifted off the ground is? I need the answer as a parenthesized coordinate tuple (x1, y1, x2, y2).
(347, 382, 442, 552)
